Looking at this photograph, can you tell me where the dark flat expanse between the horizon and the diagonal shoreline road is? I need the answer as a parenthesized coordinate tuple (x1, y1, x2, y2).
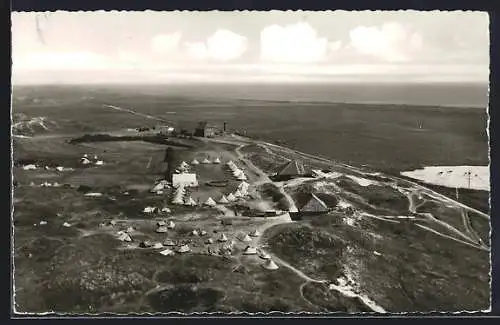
(13, 83, 489, 173)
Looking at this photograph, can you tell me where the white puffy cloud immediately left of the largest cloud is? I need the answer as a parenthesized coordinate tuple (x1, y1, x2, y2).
(184, 29, 248, 61)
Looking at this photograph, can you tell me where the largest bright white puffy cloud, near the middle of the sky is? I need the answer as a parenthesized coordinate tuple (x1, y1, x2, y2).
(260, 22, 341, 63)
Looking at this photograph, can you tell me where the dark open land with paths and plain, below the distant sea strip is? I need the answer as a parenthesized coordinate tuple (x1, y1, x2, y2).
(9, 86, 490, 313)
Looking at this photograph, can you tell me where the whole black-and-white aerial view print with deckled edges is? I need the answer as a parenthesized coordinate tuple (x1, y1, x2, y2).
(11, 10, 491, 317)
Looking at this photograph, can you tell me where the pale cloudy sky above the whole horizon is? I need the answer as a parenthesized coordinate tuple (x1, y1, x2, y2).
(11, 11, 489, 84)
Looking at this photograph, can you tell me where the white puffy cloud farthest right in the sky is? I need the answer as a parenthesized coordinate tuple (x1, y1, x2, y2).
(349, 23, 422, 62)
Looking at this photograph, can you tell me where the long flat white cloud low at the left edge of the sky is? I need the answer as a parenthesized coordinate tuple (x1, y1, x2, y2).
(12, 52, 112, 70)
